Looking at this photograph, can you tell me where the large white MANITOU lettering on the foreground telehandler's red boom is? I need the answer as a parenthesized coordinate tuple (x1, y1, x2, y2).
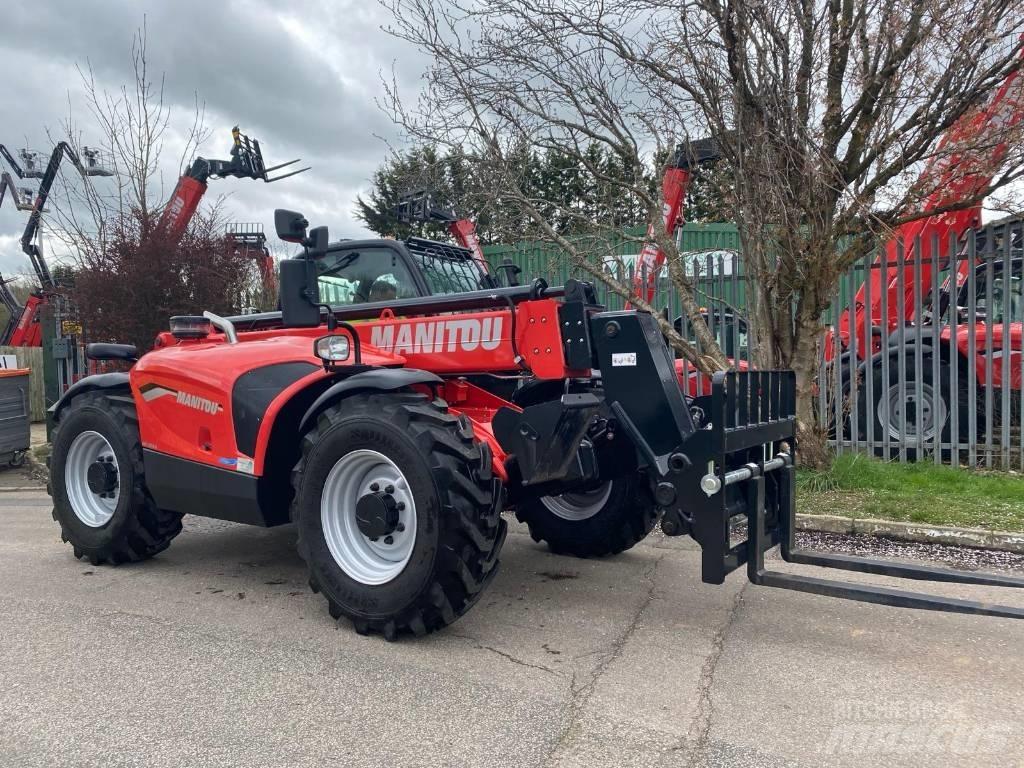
(370, 316, 504, 354)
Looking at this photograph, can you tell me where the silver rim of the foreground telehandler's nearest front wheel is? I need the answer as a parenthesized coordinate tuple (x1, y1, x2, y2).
(321, 450, 416, 586)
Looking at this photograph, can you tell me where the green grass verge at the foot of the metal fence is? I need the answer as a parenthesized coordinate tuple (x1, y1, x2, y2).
(797, 454, 1024, 531)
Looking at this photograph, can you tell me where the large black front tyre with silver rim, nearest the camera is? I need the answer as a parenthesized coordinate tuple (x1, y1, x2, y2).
(292, 392, 506, 640)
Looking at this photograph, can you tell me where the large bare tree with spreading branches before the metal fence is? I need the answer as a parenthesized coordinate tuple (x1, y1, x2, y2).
(384, 0, 1024, 464)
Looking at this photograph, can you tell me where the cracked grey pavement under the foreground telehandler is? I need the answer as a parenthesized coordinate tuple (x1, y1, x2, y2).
(0, 492, 1024, 768)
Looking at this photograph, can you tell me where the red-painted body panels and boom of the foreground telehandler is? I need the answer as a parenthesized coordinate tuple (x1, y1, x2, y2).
(130, 299, 577, 478)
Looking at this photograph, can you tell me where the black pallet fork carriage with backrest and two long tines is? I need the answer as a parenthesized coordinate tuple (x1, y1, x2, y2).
(690, 371, 1024, 618)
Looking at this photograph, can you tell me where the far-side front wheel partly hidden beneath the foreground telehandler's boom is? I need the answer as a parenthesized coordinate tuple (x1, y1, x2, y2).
(516, 473, 657, 557)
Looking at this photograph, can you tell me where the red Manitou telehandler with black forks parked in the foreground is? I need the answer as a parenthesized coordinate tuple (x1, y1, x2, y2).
(44, 211, 1024, 639)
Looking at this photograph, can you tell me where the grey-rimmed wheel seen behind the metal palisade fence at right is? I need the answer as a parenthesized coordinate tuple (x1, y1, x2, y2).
(856, 352, 970, 461)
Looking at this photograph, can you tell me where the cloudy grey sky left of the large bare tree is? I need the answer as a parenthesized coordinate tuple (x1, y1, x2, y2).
(0, 0, 424, 275)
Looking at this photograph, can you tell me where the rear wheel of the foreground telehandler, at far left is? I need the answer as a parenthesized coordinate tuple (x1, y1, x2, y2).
(47, 391, 181, 565)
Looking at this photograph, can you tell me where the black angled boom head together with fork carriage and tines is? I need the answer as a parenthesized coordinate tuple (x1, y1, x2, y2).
(591, 312, 1024, 618)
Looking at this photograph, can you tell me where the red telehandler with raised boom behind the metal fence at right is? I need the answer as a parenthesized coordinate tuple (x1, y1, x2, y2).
(824, 63, 1024, 458)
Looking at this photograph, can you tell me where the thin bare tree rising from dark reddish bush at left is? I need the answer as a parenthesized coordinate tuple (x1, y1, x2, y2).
(27, 26, 258, 348)
